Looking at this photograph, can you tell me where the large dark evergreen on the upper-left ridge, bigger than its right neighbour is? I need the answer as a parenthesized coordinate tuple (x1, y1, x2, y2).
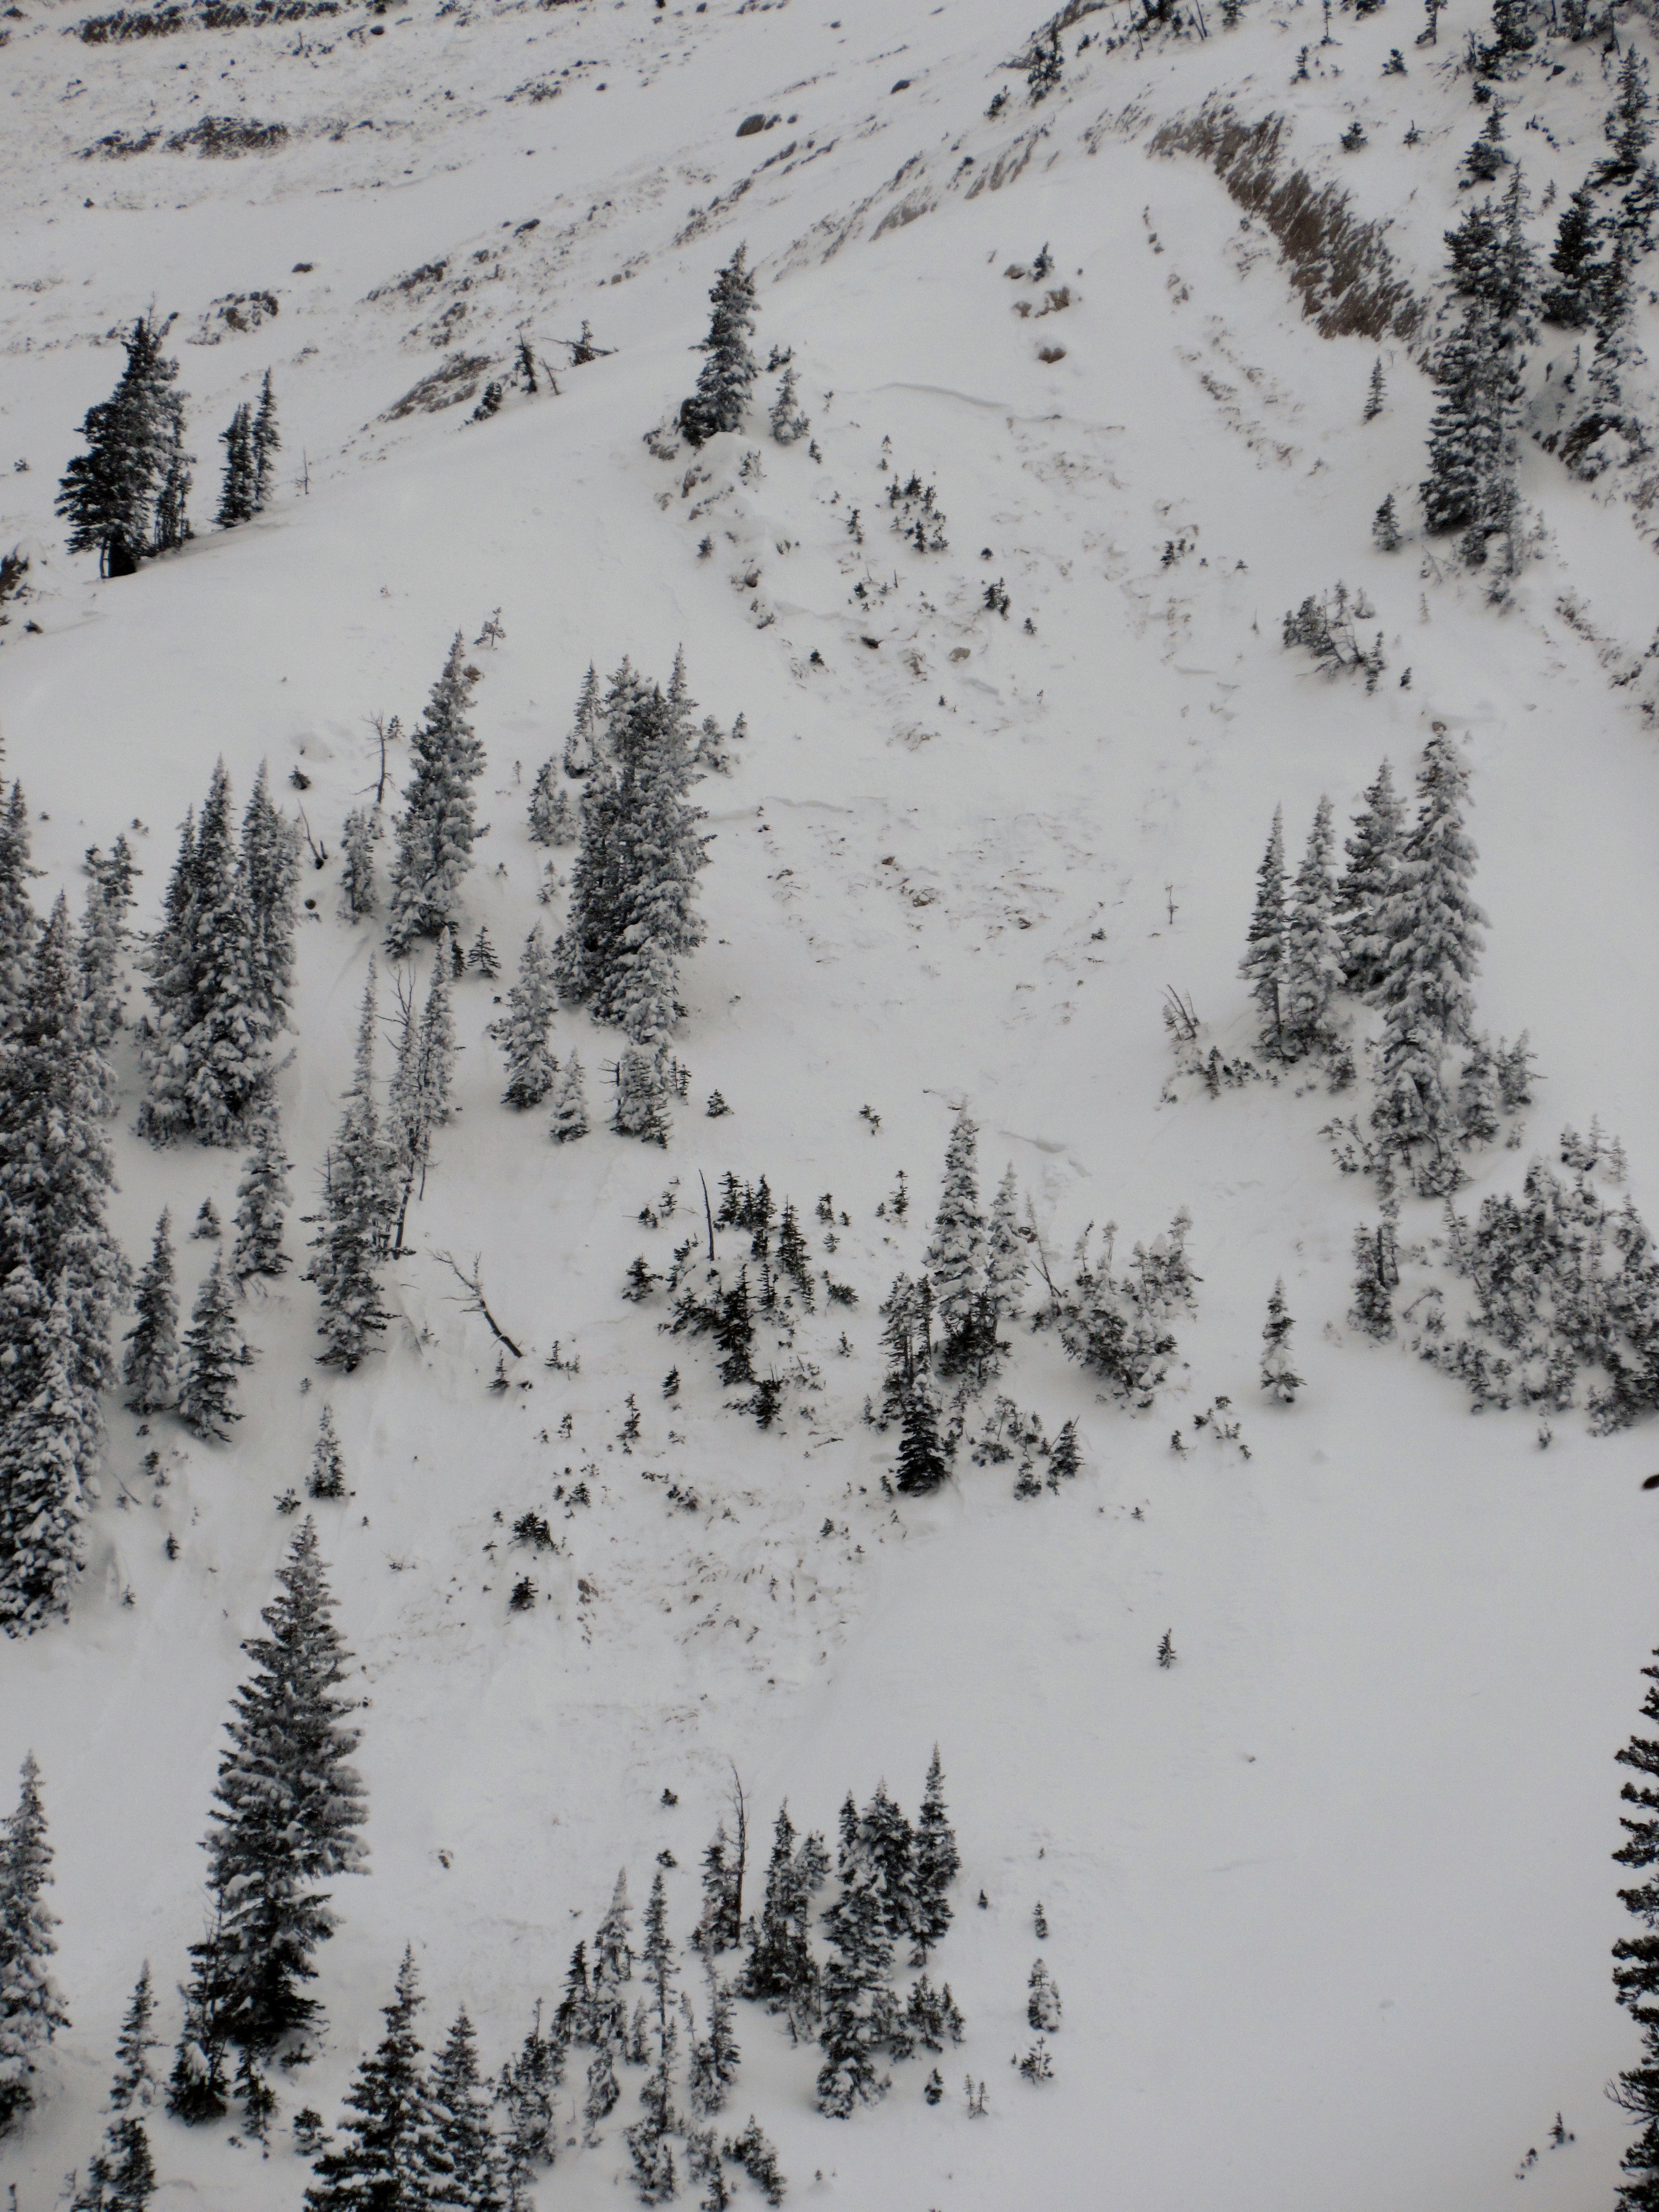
(55, 316, 181, 575)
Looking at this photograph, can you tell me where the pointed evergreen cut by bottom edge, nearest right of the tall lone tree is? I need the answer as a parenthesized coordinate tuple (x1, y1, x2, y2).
(305, 1949, 445, 2212)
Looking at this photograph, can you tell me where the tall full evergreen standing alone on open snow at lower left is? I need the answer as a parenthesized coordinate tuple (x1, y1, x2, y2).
(206, 1515, 367, 2057)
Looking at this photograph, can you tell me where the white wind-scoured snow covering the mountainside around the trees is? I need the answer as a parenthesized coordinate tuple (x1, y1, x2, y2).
(0, 0, 1659, 2212)
